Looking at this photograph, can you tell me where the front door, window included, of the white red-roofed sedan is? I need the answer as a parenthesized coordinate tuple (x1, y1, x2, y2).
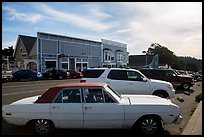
(83, 88, 124, 128)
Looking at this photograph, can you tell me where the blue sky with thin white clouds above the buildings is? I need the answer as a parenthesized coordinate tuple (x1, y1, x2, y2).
(2, 2, 202, 59)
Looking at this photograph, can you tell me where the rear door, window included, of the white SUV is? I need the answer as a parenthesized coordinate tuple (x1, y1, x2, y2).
(106, 70, 128, 94)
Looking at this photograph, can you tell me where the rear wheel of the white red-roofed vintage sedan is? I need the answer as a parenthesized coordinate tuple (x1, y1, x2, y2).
(33, 119, 54, 135)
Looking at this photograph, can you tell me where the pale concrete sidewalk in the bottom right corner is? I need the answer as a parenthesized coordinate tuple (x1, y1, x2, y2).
(181, 101, 202, 135)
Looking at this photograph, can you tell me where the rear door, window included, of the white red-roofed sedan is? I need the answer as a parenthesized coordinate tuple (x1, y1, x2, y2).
(50, 88, 83, 128)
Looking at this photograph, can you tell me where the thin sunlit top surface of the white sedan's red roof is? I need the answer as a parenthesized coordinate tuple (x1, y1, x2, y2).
(55, 82, 106, 88)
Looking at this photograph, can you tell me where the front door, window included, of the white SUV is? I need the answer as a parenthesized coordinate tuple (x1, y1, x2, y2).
(126, 70, 151, 95)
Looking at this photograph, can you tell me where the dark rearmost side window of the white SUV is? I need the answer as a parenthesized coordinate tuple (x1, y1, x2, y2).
(83, 70, 105, 78)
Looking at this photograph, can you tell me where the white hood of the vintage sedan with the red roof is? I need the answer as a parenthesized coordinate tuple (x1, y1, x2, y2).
(122, 95, 172, 105)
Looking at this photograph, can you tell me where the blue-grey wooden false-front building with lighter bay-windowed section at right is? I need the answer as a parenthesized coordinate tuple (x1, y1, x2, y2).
(37, 32, 128, 72)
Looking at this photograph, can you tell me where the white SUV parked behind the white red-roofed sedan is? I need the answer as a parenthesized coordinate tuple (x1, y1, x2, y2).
(80, 68, 175, 98)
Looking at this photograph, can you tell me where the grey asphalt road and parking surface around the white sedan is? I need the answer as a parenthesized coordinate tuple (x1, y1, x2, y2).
(2, 79, 202, 135)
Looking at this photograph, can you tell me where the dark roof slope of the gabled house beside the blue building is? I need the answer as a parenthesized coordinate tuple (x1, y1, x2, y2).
(19, 35, 37, 54)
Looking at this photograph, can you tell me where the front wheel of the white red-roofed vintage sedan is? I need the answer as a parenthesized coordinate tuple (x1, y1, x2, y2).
(138, 116, 162, 135)
